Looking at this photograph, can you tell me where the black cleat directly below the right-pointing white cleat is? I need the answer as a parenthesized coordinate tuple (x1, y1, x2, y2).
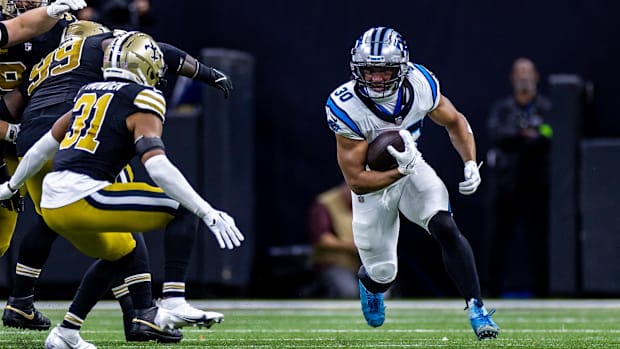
(125, 307, 183, 343)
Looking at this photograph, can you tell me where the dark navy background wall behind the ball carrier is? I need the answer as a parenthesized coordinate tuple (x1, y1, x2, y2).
(148, 0, 620, 294)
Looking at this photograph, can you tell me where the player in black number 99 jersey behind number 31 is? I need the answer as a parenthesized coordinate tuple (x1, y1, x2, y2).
(3, 21, 232, 339)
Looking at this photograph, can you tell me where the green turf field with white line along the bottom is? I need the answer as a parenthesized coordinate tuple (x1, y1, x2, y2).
(0, 300, 620, 349)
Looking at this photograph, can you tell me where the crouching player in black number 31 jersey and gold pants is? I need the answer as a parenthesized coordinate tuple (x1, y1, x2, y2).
(0, 32, 244, 348)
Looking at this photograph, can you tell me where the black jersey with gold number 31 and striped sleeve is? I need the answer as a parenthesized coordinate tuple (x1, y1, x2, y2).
(54, 81, 166, 182)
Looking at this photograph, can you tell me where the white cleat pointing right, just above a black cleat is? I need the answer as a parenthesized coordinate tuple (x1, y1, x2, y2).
(155, 297, 224, 328)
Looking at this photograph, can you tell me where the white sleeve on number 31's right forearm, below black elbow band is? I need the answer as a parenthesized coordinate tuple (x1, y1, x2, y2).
(144, 154, 213, 218)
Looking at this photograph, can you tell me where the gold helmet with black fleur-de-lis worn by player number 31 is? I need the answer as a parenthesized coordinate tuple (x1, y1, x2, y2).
(103, 31, 165, 86)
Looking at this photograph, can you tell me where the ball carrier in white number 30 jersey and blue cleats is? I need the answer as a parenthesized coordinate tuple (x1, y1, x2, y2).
(326, 27, 499, 339)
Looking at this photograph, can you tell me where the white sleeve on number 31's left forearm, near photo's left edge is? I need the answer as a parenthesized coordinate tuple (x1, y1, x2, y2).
(9, 131, 60, 189)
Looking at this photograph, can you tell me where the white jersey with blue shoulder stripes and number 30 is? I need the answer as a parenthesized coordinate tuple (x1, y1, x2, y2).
(325, 62, 440, 143)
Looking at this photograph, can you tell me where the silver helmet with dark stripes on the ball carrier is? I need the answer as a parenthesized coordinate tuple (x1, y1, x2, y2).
(351, 27, 409, 98)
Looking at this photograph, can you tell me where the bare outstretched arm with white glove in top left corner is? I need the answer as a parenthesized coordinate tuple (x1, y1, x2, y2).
(0, 0, 86, 47)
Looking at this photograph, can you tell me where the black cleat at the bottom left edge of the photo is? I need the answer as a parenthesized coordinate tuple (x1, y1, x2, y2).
(2, 296, 50, 331)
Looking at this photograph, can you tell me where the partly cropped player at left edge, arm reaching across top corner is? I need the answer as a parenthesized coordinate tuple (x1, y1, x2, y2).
(0, 0, 86, 256)
